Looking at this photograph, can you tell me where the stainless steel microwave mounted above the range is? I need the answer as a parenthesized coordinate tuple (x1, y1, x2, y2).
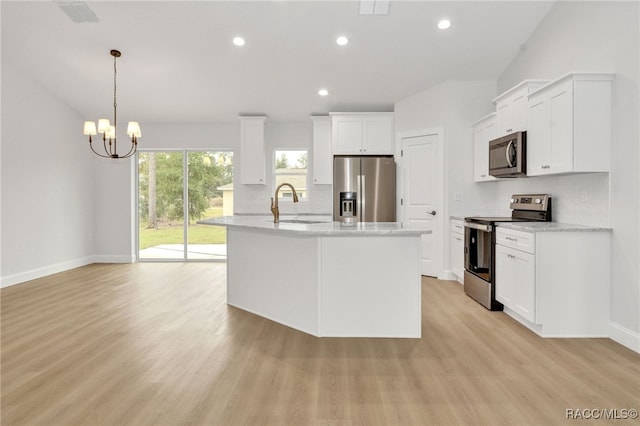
(489, 132, 527, 177)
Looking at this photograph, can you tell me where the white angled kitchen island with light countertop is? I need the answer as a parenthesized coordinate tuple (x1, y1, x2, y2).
(198, 216, 431, 338)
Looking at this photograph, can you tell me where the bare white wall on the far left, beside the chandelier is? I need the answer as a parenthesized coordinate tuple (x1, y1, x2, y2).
(1, 61, 94, 286)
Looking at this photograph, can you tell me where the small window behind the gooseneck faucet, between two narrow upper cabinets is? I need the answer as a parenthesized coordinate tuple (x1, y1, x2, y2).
(273, 149, 307, 200)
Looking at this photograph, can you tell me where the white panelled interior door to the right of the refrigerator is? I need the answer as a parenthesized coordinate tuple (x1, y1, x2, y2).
(401, 131, 443, 277)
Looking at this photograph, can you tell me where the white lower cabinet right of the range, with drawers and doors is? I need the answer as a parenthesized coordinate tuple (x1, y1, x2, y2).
(495, 223, 611, 337)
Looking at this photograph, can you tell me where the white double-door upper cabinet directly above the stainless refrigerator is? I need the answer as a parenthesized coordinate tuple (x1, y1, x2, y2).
(329, 113, 393, 155)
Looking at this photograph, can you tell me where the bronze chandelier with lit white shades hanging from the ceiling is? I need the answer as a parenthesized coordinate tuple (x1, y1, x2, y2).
(83, 50, 142, 158)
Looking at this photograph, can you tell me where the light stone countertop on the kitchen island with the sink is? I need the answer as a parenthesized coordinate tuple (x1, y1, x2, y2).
(198, 215, 431, 237)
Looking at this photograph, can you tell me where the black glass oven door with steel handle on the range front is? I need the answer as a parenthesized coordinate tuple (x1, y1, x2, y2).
(464, 222, 493, 282)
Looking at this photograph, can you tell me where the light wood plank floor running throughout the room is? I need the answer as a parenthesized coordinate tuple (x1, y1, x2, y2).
(0, 263, 640, 425)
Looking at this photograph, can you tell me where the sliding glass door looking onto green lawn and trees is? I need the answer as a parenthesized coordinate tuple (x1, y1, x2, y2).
(137, 150, 233, 261)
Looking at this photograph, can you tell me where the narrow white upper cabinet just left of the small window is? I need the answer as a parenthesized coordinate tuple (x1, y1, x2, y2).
(238, 116, 267, 185)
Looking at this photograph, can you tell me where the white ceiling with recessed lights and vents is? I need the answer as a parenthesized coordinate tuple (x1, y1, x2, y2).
(2, 0, 553, 126)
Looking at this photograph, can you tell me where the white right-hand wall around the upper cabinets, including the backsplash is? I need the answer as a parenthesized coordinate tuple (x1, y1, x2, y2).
(498, 2, 640, 350)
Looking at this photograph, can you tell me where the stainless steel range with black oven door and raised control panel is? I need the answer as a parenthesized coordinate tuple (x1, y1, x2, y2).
(464, 194, 551, 311)
